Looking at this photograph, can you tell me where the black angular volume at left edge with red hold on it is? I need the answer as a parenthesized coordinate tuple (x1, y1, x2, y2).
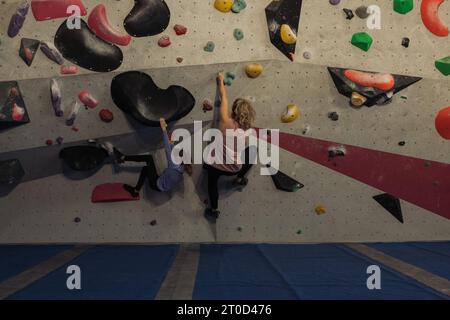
(0, 81, 30, 130)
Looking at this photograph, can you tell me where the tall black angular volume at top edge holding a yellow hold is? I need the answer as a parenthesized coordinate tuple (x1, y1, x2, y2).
(266, 0, 302, 60)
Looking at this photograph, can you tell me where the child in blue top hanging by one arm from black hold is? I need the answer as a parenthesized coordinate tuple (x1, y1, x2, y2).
(114, 118, 192, 197)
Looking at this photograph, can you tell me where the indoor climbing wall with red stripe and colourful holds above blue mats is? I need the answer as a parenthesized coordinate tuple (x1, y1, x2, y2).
(0, 0, 450, 243)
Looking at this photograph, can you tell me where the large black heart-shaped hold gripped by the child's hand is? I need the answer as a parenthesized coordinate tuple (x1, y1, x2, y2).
(111, 71, 195, 127)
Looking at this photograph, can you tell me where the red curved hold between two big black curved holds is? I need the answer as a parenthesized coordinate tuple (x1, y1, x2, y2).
(88, 4, 131, 46)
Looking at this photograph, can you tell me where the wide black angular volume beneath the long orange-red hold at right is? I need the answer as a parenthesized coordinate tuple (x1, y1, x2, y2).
(328, 67, 422, 107)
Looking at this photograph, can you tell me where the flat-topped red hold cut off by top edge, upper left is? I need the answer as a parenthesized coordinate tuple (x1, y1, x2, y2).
(31, 0, 87, 21)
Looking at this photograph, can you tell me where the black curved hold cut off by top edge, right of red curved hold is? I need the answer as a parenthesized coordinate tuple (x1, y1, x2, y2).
(123, 0, 170, 37)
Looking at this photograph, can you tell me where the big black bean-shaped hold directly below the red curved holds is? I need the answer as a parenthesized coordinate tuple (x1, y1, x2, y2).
(55, 20, 123, 72)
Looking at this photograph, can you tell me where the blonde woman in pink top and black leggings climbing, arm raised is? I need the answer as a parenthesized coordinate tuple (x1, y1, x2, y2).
(204, 73, 256, 222)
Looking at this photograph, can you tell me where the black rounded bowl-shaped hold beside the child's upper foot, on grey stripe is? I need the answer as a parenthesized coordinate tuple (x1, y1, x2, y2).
(59, 145, 108, 171)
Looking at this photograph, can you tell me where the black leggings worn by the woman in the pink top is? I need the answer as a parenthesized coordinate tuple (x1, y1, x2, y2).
(203, 148, 252, 210)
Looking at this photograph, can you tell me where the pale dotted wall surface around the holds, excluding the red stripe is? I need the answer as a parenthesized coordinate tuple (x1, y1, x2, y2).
(0, 0, 450, 243)
